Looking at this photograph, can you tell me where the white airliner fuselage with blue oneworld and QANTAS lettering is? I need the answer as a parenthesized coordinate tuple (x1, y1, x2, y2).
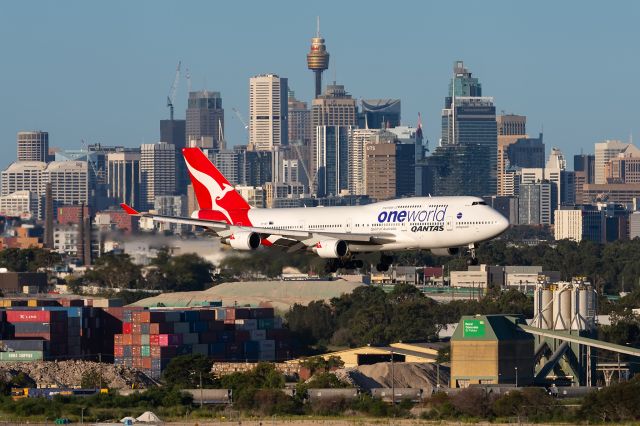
(242, 197, 509, 253)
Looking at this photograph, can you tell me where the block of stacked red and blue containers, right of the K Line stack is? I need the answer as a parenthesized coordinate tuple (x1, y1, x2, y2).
(114, 307, 290, 378)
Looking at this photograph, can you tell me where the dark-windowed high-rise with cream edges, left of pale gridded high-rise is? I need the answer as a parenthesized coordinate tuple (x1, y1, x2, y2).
(107, 149, 141, 208)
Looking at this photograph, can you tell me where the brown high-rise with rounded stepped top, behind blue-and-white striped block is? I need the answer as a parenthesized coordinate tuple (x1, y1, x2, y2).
(309, 83, 357, 190)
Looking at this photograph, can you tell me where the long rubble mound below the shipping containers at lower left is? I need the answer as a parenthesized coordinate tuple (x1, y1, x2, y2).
(0, 361, 154, 389)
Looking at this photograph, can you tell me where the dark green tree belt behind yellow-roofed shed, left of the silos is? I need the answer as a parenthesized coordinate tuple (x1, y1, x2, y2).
(285, 284, 533, 352)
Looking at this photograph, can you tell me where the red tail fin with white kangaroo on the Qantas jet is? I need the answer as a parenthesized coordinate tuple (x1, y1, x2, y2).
(182, 148, 251, 224)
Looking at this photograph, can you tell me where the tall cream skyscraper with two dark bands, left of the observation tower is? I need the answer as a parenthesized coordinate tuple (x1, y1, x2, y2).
(249, 74, 289, 151)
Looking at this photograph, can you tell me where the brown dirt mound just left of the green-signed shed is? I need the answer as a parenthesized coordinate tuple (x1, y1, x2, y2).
(336, 362, 449, 394)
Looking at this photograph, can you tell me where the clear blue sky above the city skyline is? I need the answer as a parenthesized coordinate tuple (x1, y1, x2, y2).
(0, 0, 640, 168)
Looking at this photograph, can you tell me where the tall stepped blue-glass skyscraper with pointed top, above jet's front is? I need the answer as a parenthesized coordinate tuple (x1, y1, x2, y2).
(428, 61, 497, 196)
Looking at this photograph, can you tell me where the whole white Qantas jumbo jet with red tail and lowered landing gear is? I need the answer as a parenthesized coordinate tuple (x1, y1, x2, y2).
(122, 148, 509, 272)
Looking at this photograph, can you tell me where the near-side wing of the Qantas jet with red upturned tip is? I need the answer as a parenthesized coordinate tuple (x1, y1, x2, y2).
(121, 204, 395, 252)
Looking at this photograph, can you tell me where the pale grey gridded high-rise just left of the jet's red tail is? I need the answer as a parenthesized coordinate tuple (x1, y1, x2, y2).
(140, 142, 176, 210)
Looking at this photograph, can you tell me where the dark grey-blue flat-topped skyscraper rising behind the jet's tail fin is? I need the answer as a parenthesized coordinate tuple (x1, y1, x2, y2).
(185, 90, 224, 149)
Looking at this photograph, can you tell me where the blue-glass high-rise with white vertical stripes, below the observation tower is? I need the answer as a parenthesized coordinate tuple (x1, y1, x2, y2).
(314, 126, 349, 197)
